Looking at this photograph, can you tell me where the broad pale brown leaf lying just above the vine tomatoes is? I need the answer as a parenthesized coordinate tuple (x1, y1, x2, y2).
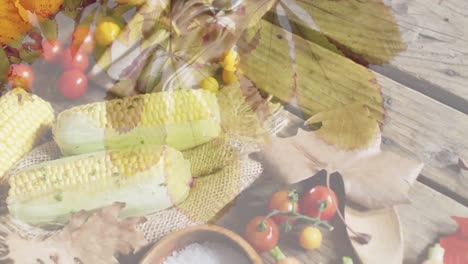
(260, 127, 423, 209)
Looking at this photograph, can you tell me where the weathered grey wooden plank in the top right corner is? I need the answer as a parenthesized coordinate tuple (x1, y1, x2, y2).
(385, 0, 468, 104)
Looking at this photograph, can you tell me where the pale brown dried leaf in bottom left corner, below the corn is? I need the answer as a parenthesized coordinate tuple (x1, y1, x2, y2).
(0, 203, 148, 264)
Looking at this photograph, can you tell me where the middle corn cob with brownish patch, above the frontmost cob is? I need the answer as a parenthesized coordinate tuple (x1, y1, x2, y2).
(53, 89, 221, 155)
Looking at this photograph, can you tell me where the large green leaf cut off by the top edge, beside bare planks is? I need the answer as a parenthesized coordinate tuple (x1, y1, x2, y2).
(282, 0, 406, 64)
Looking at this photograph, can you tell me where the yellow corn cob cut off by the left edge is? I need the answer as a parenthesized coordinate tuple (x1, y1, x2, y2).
(0, 88, 54, 177)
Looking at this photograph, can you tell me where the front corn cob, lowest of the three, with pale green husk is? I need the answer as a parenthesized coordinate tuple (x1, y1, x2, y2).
(7, 146, 192, 225)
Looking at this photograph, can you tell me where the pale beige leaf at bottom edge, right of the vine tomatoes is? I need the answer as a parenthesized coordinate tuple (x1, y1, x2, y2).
(345, 207, 403, 264)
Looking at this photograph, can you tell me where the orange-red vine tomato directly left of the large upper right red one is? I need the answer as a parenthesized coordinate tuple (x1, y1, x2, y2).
(268, 190, 299, 225)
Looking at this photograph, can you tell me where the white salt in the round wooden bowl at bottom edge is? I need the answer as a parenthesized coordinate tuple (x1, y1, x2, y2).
(164, 242, 250, 264)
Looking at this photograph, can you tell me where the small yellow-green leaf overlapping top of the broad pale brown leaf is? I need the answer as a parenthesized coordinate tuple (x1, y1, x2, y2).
(306, 103, 380, 149)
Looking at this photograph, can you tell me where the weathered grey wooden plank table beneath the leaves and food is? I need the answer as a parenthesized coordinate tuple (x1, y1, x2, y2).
(218, 5, 468, 263)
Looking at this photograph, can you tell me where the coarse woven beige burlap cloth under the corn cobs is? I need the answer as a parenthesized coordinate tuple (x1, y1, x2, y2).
(0, 138, 262, 242)
